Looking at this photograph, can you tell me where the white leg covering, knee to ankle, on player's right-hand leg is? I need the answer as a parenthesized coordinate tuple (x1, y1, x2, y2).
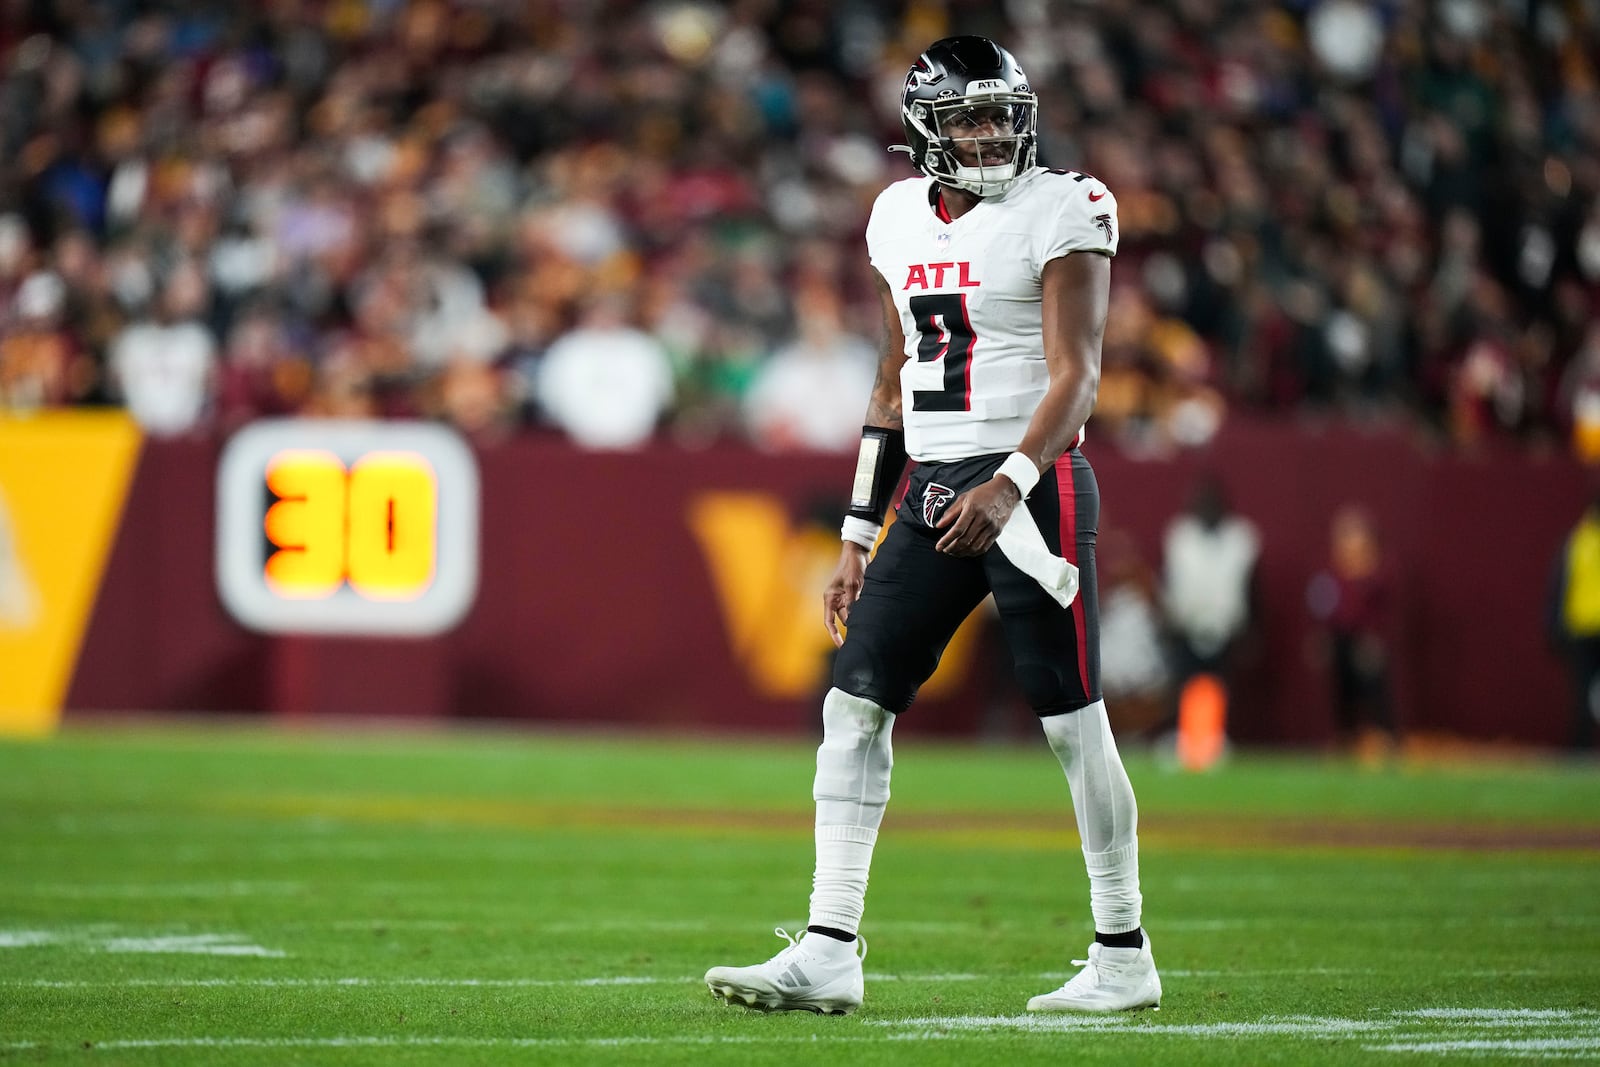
(1040, 701, 1142, 934)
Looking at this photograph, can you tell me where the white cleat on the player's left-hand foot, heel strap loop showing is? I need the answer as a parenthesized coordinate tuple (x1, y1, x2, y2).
(706, 928, 867, 1016)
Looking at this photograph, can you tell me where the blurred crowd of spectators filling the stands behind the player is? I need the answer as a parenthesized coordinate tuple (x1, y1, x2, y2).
(0, 0, 1600, 459)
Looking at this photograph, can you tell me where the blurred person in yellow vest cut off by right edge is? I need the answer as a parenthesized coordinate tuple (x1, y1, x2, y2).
(1547, 496, 1600, 749)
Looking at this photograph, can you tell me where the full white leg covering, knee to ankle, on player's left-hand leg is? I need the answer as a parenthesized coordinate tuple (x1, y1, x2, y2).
(810, 689, 894, 934)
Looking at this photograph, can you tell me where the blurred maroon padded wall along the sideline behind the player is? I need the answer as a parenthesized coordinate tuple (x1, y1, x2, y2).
(67, 421, 1589, 744)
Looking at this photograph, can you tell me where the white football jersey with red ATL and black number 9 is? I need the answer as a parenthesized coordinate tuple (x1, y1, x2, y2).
(867, 166, 1117, 461)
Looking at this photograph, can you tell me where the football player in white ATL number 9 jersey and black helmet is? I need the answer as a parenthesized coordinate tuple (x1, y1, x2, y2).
(706, 37, 1162, 1014)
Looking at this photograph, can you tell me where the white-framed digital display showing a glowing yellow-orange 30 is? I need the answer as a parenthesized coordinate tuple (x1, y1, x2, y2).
(216, 419, 478, 635)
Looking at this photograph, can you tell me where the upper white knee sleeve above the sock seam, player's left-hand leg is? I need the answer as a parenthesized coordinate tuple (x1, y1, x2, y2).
(811, 689, 894, 830)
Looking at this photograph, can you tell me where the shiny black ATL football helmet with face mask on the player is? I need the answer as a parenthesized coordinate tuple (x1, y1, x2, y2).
(894, 37, 1038, 197)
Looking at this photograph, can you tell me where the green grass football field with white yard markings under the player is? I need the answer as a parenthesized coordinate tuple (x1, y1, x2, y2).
(0, 723, 1600, 1067)
